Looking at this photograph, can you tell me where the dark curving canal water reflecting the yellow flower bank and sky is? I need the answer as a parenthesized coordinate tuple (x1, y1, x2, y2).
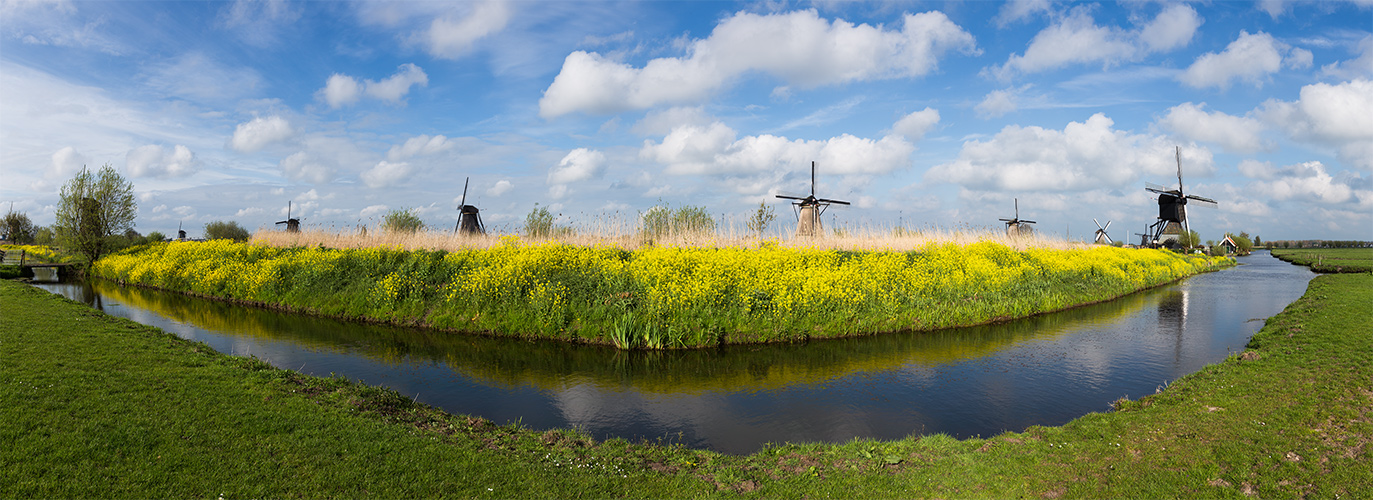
(38, 253, 1314, 453)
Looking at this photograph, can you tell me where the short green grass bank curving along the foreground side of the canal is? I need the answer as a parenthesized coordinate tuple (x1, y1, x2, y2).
(0, 265, 1373, 499)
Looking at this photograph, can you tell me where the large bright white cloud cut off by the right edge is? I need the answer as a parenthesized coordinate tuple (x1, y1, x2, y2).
(1259, 80, 1373, 170)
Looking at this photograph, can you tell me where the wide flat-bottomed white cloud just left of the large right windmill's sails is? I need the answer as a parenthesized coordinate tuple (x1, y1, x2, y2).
(925, 113, 1214, 191)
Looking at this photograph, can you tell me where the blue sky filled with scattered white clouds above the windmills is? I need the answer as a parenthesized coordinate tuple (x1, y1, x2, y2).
(0, 0, 1373, 242)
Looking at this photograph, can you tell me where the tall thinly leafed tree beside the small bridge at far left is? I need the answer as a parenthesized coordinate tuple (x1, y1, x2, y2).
(54, 163, 139, 262)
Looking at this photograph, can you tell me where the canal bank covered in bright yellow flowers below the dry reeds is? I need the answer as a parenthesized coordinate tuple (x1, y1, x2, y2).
(92, 236, 1233, 349)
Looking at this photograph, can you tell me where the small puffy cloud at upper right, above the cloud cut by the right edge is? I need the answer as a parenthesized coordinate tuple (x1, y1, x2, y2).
(1178, 30, 1311, 89)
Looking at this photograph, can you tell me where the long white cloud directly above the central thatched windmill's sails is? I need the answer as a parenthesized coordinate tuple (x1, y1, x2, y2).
(638, 118, 919, 176)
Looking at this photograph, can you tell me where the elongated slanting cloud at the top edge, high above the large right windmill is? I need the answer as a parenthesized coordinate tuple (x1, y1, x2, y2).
(987, 5, 1201, 81)
